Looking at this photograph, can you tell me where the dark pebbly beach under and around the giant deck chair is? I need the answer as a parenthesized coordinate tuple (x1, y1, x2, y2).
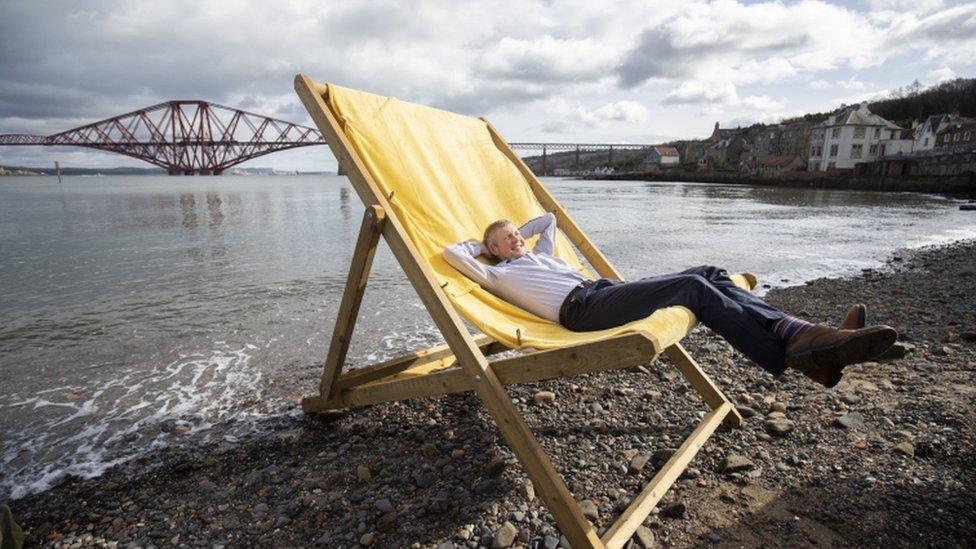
(11, 240, 976, 547)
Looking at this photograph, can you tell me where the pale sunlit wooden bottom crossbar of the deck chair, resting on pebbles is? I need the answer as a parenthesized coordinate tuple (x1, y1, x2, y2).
(603, 402, 735, 548)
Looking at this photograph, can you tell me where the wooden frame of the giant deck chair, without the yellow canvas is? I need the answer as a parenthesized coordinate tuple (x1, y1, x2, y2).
(295, 75, 755, 548)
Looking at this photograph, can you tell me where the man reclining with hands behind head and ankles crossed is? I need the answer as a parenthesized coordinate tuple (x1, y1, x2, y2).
(444, 213, 897, 387)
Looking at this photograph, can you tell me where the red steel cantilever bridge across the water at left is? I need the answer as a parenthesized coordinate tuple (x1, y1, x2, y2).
(0, 101, 325, 175)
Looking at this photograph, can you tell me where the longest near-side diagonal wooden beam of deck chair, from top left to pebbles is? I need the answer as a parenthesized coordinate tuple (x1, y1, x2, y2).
(295, 75, 603, 548)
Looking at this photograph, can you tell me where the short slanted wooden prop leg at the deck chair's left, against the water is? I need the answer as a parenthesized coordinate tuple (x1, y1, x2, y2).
(319, 206, 386, 398)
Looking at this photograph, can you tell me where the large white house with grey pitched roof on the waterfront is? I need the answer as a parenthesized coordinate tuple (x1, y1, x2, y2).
(807, 103, 902, 172)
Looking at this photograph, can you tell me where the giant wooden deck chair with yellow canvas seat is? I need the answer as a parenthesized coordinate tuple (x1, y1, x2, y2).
(295, 75, 755, 548)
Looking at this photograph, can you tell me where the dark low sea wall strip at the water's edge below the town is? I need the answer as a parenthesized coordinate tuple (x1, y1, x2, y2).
(585, 172, 976, 199)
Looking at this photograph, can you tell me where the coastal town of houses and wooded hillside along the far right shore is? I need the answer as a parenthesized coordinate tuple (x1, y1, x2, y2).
(530, 77, 976, 181)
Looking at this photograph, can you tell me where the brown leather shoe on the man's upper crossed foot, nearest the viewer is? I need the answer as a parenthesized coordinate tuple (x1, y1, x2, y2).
(786, 324, 898, 388)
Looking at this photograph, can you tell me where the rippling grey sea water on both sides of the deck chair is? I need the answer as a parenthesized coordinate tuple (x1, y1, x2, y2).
(0, 177, 976, 500)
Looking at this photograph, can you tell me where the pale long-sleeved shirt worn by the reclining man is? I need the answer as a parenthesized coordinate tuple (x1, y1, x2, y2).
(444, 213, 587, 322)
